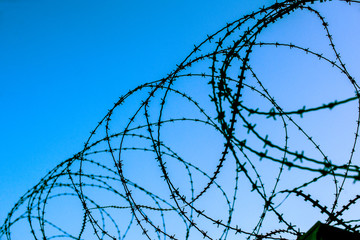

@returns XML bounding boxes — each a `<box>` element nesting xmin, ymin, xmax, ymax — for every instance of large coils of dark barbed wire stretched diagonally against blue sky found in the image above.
<box><xmin>0</xmin><ymin>0</ymin><xmax>360</xmax><ymax>240</ymax></box>
